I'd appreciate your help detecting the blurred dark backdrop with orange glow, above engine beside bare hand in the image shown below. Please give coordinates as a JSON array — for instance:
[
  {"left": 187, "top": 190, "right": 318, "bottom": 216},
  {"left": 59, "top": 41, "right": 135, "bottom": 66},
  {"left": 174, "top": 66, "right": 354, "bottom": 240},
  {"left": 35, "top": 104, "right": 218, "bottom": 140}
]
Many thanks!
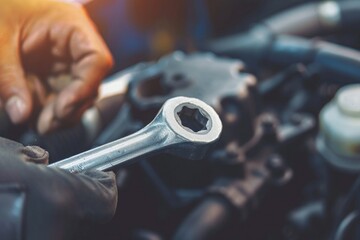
[{"left": 87, "top": 0, "right": 321, "bottom": 71}]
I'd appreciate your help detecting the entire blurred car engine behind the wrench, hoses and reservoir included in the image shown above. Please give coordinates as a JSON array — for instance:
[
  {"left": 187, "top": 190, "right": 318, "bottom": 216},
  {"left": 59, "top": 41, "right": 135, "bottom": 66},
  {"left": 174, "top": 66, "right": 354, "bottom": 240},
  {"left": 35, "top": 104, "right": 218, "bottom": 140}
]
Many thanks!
[{"left": 0, "top": 0, "right": 360, "bottom": 240}]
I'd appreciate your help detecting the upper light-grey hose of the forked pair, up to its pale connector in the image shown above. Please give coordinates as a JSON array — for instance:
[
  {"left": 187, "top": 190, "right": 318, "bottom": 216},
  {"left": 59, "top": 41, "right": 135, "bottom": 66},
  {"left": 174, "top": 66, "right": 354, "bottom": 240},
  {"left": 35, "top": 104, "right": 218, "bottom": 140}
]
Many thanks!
[{"left": 205, "top": 3, "right": 322, "bottom": 59}]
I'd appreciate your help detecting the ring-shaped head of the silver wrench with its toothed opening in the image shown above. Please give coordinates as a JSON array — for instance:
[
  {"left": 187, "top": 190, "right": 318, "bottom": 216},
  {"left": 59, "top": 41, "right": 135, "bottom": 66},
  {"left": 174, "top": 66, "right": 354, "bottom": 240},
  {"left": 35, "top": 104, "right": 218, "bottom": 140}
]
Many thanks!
[{"left": 160, "top": 97, "right": 222, "bottom": 159}]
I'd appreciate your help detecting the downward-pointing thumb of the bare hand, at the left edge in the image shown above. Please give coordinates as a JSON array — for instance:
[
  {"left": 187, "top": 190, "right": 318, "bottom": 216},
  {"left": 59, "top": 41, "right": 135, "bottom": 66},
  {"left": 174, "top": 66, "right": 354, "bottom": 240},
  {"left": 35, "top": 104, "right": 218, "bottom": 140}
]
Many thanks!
[{"left": 0, "top": 29, "right": 32, "bottom": 124}]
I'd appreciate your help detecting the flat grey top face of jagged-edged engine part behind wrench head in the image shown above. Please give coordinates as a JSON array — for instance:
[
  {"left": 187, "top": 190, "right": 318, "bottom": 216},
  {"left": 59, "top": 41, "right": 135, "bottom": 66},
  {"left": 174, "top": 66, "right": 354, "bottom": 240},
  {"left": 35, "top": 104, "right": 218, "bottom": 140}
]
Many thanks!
[{"left": 129, "top": 52, "right": 257, "bottom": 110}]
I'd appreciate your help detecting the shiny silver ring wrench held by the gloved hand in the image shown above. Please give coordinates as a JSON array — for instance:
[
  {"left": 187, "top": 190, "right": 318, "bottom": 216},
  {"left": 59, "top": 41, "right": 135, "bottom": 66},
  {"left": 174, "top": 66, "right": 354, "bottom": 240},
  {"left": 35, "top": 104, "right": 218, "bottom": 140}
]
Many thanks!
[{"left": 49, "top": 97, "right": 222, "bottom": 173}]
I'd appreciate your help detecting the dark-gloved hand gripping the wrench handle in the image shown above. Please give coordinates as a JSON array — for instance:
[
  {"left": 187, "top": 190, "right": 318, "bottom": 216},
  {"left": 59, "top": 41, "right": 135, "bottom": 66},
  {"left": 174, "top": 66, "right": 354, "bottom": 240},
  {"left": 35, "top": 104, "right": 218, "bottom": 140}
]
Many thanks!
[{"left": 0, "top": 138, "right": 117, "bottom": 240}]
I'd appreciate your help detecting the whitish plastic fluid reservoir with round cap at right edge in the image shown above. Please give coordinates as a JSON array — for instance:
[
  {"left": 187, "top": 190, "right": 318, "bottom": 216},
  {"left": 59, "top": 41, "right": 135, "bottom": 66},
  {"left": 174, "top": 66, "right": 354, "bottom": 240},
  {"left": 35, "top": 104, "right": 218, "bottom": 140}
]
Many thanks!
[{"left": 317, "top": 84, "right": 360, "bottom": 172}]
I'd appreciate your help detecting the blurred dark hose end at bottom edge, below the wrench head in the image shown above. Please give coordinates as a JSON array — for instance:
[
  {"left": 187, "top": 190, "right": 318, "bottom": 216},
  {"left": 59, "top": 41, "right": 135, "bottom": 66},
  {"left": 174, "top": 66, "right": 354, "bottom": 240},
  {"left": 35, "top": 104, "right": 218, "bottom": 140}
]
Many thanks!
[{"left": 173, "top": 197, "right": 235, "bottom": 240}]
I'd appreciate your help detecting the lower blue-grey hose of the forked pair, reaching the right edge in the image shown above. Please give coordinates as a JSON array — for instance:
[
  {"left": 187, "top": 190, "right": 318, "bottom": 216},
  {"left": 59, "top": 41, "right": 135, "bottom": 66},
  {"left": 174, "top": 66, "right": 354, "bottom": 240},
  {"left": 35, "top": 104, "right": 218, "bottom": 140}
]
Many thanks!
[{"left": 211, "top": 28, "right": 360, "bottom": 82}]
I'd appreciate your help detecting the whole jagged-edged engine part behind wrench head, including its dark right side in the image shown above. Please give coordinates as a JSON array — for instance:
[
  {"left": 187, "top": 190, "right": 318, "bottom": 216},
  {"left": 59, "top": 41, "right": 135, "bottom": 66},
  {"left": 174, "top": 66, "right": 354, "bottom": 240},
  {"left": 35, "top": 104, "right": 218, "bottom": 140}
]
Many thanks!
[{"left": 128, "top": 52, "right": 259, "bottom": 142}]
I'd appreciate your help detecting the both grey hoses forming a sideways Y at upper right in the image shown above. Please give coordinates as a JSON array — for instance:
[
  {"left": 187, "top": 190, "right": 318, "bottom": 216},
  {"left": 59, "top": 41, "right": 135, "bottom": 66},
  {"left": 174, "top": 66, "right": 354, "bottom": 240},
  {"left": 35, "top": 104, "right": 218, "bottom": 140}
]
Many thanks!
[{"left": 207, "top": 1, "right": 360, "bottom": 76}]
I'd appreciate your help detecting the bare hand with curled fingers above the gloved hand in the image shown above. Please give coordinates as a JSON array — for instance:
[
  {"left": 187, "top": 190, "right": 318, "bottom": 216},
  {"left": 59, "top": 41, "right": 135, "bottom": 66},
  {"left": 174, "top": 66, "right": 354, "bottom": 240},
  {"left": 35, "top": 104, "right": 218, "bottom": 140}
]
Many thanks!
[{"left": 0, "top": 0, "right": 113, "bottom": 134}]
